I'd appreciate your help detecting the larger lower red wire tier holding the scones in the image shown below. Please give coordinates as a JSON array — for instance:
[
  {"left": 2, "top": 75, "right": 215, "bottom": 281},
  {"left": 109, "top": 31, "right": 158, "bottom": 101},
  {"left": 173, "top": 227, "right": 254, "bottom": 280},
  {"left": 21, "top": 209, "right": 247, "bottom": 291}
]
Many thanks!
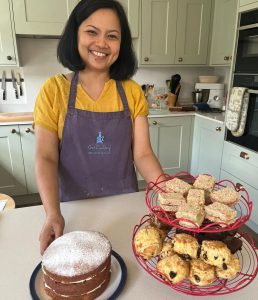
[{"left": 132, "top": 215, "right": 258, "bottom": 296}]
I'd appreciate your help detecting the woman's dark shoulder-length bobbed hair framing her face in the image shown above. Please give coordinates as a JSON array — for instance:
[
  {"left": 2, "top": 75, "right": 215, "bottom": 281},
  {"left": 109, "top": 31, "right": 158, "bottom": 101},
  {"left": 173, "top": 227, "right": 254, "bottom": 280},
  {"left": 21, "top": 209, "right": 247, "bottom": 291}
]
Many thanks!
[{"left": 57, "top": 0, "right": 137, "bottom": 80}]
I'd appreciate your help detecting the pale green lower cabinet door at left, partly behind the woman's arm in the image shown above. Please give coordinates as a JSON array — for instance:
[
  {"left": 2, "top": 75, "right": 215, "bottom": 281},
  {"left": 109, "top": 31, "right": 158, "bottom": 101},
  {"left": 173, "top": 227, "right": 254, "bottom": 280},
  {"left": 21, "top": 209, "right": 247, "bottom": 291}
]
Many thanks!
[{"left": 19, "top": 125, "right": 38, "bottom": 194}]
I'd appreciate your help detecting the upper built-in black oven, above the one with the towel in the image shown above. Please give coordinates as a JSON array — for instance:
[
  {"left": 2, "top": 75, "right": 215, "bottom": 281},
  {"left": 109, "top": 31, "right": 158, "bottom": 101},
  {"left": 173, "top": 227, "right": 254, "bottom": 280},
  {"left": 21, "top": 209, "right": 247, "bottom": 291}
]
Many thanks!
[{"left": 234, "top": 9, "right": 258, "bottom": 74}]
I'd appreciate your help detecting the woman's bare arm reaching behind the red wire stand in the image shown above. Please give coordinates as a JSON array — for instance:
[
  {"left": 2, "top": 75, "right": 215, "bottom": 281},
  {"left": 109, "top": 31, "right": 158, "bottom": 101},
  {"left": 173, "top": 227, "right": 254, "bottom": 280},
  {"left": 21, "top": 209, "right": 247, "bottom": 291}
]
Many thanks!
[{"left": 133, "top": 116, "right": 164, "bottom": 183}]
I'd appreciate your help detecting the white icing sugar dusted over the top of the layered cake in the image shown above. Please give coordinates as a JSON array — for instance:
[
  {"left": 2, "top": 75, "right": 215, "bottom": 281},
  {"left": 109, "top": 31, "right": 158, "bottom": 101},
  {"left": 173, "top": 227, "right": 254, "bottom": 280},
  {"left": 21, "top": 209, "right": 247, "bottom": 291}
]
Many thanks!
[{"left": 42, "top": 231, "right": 111, "bottom": 277}]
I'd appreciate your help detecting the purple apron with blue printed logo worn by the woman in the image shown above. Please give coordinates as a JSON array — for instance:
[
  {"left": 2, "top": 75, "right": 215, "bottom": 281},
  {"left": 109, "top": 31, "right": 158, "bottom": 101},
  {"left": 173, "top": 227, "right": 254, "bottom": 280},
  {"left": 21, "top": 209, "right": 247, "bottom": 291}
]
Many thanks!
[{"left": 59, "top": 72, "right": 138, "bottom": 201}]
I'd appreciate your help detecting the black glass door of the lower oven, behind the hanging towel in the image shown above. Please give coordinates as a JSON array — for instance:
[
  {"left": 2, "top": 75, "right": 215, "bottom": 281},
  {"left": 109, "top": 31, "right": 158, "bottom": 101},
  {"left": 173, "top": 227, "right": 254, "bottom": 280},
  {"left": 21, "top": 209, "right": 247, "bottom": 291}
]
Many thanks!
[{"left": 226, "top": 89, "right": 258, "bottom": 152}]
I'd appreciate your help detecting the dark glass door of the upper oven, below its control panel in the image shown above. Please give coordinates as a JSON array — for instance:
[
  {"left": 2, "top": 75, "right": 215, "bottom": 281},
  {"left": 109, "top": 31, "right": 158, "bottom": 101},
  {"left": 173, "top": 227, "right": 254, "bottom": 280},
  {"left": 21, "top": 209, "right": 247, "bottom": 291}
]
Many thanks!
[{"left": 235, "top": 24, "right": 258, "bottom": 74}]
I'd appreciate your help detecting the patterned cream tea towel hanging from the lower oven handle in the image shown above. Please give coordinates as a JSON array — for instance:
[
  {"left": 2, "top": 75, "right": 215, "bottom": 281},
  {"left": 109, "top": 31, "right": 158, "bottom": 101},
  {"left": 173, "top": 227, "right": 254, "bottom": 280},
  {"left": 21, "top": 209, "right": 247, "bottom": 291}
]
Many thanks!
[{"left": 226, "top": 87, "right": 247, "bottom": 131}]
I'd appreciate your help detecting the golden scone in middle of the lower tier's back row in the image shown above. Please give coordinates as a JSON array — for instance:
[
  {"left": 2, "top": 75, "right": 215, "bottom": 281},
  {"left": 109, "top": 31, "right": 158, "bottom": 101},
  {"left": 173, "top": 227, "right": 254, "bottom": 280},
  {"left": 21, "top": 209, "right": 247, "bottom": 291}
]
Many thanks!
[{"left": 172, "top": 233, "right": 199, "bottom": 258}]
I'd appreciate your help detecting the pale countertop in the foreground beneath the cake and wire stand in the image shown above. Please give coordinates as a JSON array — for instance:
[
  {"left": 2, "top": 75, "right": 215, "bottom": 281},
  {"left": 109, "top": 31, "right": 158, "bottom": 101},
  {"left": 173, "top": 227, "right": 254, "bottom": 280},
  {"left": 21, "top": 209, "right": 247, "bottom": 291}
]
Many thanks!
[{"left": 0, "top": 192, "right": 258, "bottom": 300}]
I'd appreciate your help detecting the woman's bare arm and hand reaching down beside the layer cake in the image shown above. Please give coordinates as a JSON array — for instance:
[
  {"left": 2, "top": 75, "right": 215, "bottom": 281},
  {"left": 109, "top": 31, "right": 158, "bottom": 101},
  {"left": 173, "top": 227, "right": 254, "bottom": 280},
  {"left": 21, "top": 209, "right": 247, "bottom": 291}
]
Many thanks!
[{"left": 35, "top": 125, "right": 64, "bottom": 254}]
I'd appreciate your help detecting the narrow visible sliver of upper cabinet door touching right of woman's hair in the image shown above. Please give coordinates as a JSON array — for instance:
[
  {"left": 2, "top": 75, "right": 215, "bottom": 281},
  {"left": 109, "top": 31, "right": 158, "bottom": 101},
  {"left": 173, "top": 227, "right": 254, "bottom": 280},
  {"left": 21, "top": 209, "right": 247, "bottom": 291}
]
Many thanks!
[{"left": 119, "top": 0, "right": 140, "bottom": 38}]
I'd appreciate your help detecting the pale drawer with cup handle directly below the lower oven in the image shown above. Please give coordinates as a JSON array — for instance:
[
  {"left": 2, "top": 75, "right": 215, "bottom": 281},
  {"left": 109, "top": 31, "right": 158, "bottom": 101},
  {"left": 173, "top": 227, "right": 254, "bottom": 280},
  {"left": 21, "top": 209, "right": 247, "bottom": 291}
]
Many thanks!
[{"left": 221, "top": 142, "right": 258, "bottom": 189}]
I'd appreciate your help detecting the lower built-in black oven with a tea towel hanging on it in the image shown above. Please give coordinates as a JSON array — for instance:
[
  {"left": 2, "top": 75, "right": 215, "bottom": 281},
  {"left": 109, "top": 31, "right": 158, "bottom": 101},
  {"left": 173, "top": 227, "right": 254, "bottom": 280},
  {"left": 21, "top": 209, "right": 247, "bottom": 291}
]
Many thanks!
[{"left": 226, "top": 74, "right": 258, "bottom": 152}]
